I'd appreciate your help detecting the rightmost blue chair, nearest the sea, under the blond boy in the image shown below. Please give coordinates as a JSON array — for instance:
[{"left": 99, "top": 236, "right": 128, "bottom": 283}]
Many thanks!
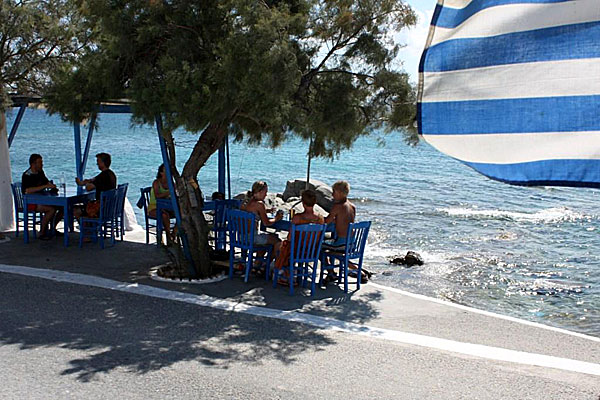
[{"left": 319, "top": 221, "right": 371, "bottom": 293}]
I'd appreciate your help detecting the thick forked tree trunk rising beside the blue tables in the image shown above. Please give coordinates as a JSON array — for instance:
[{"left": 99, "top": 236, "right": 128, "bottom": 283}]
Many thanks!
[{"left": 164, "top": 124, "right": 227, "bottom": 278}]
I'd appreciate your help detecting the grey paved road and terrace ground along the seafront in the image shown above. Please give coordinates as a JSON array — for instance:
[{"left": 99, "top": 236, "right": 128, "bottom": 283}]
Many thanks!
[{"left": 0, "top": 228, "right": 600, "bottom": 400}]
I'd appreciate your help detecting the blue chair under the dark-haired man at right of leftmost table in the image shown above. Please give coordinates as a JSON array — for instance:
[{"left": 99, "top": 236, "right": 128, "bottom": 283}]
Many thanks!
[{"left": 79, "top": 189, "right": 117, "bottom": 249}]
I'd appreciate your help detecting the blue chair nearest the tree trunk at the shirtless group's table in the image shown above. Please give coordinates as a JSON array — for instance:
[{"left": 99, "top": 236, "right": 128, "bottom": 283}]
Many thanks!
[{"left": 226, "top": 209, "right": 273, "bottom": 282}]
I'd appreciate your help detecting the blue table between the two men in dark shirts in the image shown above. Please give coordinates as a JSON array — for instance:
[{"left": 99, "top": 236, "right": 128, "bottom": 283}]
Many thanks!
[{"left": 23, "top": 190, "right": 96, "bottom": 247}]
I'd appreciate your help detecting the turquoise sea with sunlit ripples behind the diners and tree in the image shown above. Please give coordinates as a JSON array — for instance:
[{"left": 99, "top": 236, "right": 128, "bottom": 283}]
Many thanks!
[{"left": 9, "top": 109, "right": 600, "bottom": 336}]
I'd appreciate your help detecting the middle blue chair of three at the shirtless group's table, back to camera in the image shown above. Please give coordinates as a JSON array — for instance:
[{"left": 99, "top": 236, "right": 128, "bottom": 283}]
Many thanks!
[{"left": 273, "top": 224, "right": 327, "bottom": 296}]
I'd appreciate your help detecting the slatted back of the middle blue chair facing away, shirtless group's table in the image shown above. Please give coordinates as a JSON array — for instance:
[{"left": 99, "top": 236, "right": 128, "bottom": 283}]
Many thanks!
[{"left": 290, "top": 224, "right": 327, "bottom": 267}]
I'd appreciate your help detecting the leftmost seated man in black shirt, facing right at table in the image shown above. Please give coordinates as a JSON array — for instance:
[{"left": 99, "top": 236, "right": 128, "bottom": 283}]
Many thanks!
[{"left": 21, "top": 154, "right": 63, "bottom": 240}]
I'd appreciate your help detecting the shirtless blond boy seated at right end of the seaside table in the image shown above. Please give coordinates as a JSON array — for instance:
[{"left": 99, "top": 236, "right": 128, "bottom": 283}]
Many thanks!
[{"left": 323, "top": 181, "right": 356, "bottom": 248}]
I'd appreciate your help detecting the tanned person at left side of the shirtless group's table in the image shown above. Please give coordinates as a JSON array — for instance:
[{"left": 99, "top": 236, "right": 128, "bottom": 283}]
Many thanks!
[{"left": 240, "top": 181, "right": 283, "bottom": 262}]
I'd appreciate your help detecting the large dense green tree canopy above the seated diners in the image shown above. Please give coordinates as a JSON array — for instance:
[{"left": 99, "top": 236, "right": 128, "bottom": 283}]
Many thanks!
[{"left": 48, "top": 0, "right": 415, "bottom": 159}]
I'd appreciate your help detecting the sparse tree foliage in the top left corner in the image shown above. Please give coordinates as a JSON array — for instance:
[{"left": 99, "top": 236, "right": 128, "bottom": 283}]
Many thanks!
[{"left": 0, "top": 0, "right": 86, "bottom": 111}]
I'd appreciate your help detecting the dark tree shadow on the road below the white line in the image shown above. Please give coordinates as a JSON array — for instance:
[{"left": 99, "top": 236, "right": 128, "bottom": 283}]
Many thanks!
[{"left": 0, "top": 274, "right": 336, "bottom": 382}]
